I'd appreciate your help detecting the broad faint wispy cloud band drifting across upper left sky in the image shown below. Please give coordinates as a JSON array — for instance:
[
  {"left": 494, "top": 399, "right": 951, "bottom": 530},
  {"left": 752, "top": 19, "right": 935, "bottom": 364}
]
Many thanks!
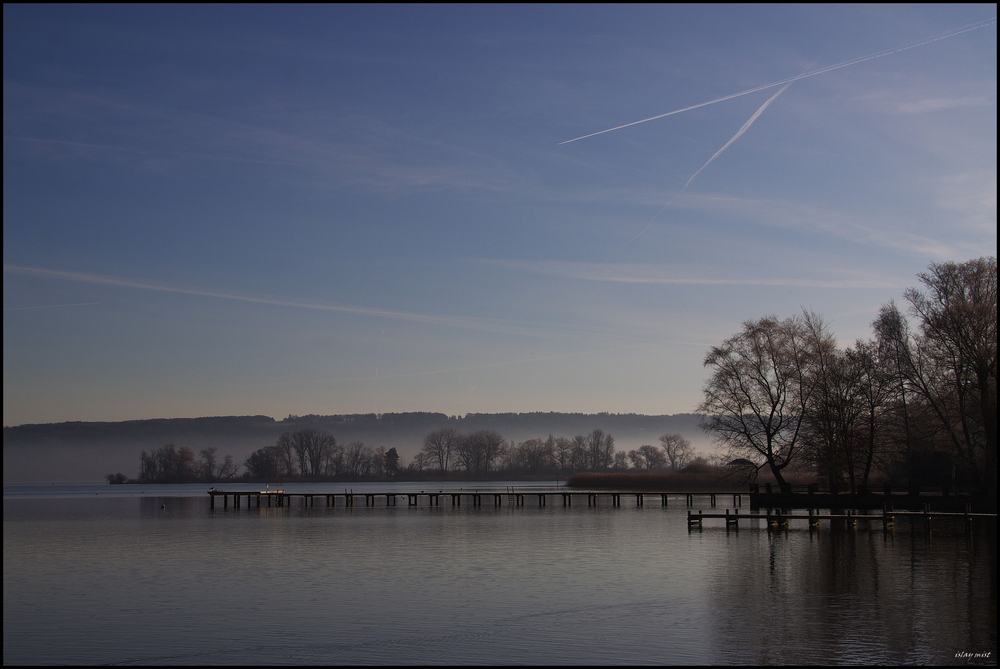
[{"left": 4, "top": 82, "right": 517, "bottom": 192}]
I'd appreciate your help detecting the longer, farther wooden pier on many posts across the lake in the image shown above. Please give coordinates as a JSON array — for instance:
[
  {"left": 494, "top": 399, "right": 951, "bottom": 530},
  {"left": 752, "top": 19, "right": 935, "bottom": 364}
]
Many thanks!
[{"left": 208, "top": 487, "right": 746, "bottom": 509}]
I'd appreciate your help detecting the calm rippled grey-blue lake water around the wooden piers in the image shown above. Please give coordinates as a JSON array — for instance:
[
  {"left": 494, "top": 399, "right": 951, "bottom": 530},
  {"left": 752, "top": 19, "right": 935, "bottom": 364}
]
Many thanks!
[{"left": 3, "top": 483, "right": 997, "bottom": 665}]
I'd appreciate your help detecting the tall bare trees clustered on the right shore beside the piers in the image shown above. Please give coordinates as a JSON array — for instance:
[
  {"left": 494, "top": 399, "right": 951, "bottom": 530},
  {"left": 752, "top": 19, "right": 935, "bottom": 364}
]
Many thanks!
[{"left": 698, "top": 257, "right": 997, "bottom": 504}]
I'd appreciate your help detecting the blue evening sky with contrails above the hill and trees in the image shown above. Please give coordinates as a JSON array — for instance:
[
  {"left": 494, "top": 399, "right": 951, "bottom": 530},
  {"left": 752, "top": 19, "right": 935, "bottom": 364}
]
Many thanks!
[{"left": 3, "top": 4, "right": 997, "bottom": 425}]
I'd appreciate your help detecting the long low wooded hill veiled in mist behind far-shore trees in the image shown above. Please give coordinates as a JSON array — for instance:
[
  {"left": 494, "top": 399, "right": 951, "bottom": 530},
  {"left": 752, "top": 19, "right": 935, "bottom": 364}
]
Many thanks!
[{"left": 3, "top": 412, "right": 708, "bottom": 483}]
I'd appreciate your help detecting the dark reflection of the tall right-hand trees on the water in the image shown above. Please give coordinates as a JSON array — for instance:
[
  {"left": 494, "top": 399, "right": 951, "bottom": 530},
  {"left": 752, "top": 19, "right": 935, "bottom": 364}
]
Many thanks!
[{"left": 705, "top": 527, "right": 996, "bottom": 665}]
